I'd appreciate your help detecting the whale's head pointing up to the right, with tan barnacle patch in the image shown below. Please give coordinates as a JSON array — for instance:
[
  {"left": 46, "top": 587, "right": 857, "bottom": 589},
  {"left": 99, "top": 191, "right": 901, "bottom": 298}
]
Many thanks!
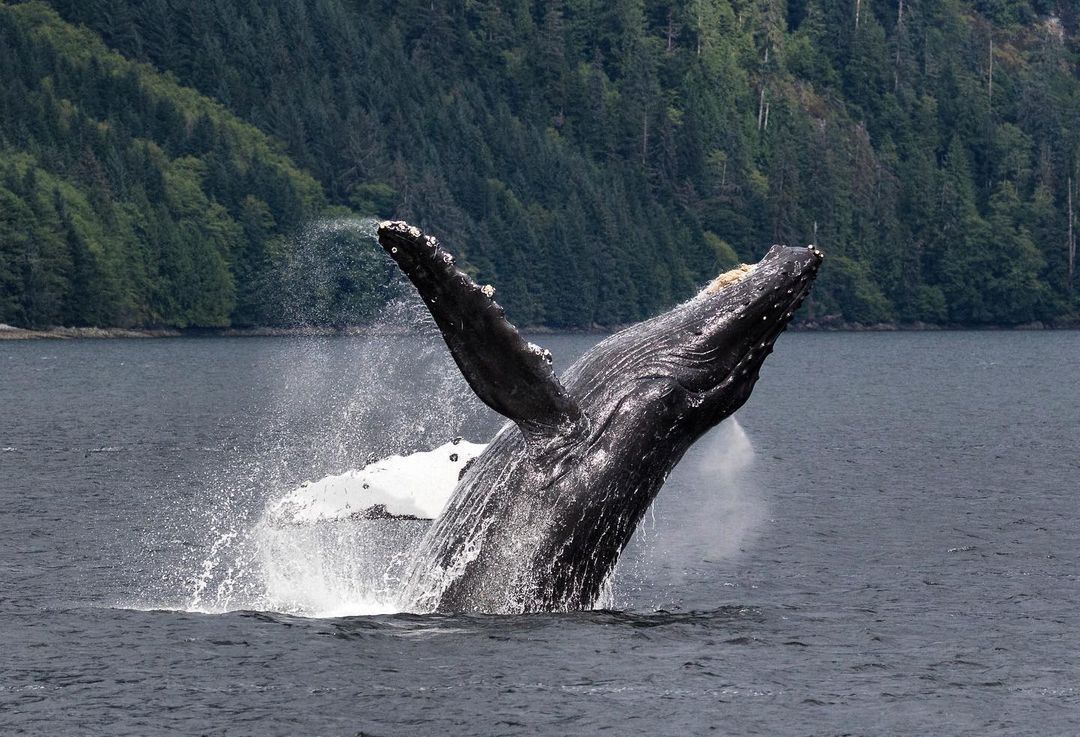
[{"left": 564, "top": 245, "right": 823, "bottom": 438}]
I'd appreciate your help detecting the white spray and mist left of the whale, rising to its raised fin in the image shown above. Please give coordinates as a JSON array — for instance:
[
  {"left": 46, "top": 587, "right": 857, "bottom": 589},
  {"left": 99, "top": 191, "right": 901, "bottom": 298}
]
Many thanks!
[{"left": 135, "top": 219, "right": 486, "bottom": 616}]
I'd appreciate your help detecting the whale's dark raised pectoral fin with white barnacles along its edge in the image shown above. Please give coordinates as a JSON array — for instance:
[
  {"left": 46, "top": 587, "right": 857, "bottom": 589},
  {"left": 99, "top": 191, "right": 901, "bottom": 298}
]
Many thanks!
[{"left": 379, "top": 222, "right": 581, "bottom": 439}]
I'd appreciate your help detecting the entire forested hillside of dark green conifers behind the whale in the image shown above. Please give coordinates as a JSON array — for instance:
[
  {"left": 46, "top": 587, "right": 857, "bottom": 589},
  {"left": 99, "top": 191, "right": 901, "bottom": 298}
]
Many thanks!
[{"left": 0, "top": 0, "right": 1080, "bottom": 326}]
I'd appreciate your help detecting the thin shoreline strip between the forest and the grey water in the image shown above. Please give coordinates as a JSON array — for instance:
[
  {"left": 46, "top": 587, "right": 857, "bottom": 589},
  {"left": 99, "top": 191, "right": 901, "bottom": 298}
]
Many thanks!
[{"left": 0, "top": 321, "right": 1080, "bottom": 341}]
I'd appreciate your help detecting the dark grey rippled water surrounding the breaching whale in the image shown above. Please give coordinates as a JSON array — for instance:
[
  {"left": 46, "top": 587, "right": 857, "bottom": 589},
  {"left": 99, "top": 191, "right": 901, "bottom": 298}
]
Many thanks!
[{"left": 0, "top": 333, "right": 1080, "bottom": 736}]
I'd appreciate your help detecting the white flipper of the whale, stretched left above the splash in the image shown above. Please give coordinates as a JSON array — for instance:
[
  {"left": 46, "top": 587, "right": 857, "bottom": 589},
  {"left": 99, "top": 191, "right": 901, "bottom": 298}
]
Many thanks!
[{"left": 267, "top": 440, "right": 487, "bottom": 525}]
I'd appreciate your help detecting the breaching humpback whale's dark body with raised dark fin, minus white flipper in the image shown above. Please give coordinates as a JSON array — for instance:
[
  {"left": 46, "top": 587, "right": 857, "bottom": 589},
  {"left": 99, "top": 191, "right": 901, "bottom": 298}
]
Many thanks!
[{"left": 378, "top": 222, "right": 823, "bottom": 613}]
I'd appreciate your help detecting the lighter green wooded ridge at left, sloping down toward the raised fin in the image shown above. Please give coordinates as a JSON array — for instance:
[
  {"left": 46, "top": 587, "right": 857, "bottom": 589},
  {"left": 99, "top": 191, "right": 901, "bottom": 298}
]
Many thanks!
[{"left": 0, "top": 3, "right": 382, "bottom": 326}]
